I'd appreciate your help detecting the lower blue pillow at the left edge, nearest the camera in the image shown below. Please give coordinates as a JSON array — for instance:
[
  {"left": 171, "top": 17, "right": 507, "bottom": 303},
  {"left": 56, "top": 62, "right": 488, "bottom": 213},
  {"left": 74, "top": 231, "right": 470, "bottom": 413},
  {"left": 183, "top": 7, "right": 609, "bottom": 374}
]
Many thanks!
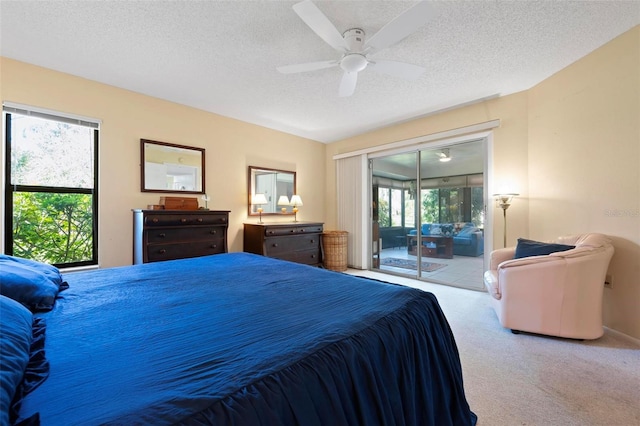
[{"left": 0, "top": 296, "right": 33, "bottom": 425}]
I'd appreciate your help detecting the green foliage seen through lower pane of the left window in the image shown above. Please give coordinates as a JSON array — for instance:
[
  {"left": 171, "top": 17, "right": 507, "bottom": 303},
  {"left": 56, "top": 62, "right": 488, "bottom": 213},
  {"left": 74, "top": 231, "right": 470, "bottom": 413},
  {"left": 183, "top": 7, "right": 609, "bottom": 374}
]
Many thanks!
[{"left": 13, "top": 192, "right": 93, "bottom": 264}]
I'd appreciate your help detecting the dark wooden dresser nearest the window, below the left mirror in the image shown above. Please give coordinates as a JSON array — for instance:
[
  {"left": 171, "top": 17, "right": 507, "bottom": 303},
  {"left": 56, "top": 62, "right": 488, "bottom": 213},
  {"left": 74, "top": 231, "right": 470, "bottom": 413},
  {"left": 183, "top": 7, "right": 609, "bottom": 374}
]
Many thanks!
[{"left": 133, "top": 209, "right": 229, "bottom": 264}]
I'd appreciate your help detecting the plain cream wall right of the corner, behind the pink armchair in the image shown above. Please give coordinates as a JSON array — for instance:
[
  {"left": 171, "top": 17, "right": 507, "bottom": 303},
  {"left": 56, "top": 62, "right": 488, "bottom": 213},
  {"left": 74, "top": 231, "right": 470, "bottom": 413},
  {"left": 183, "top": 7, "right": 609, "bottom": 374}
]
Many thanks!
[{"left": 528, "top": 27, "right": 640, "bottom": 338}]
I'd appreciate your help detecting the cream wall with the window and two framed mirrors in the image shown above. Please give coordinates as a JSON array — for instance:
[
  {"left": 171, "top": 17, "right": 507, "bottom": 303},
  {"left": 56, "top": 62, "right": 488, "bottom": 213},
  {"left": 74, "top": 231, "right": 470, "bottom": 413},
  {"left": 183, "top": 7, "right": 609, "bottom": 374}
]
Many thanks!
[{"left": 0, "top": 58, "right": 325, "bottom": 267}]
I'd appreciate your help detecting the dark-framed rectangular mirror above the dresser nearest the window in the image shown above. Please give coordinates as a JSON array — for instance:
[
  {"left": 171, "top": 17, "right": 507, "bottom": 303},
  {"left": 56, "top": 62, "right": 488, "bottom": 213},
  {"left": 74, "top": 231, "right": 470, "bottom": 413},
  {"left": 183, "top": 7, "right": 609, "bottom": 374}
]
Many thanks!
[{"left": 140, "top": 139, "right": 205, "bottom": 194}]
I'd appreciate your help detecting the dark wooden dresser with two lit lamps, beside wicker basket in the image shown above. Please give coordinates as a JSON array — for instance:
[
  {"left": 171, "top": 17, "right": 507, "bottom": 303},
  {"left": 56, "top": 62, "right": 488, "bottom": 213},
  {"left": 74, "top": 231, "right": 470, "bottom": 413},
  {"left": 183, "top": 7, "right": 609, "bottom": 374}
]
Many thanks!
[{"left": 244, "top": 222, "right": 323, "bottom": 266}]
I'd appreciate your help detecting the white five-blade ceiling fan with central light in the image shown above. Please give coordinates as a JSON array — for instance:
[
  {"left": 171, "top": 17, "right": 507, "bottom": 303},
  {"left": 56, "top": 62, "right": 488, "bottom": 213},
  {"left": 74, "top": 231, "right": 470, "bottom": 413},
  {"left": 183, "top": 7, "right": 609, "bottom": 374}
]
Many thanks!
[{"left": 276, "top": 0, "right": 435, "bottom": 97}]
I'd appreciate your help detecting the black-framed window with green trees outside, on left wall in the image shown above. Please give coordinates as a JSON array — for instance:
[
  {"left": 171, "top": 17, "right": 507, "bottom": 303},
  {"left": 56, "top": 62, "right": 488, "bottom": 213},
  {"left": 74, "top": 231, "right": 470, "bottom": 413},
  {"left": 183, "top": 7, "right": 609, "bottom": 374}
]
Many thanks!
[{"left": 4, "top": 106, "right": 99, "bottom": 267}]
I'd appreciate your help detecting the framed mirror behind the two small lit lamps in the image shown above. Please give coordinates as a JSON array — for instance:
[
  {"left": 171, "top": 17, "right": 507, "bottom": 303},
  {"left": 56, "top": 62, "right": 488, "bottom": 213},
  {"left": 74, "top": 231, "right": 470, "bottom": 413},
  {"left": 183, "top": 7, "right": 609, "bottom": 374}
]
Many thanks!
[{"left": 247, "top": 166, "right": 296, "bottom": 216}]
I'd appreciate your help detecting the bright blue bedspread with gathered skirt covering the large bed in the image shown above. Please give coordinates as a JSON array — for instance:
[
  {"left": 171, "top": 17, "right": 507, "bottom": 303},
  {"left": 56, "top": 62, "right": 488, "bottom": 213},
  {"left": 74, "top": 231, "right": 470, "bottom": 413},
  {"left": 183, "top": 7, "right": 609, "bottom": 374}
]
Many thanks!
[{"left": 0, "top": 253, "right": 476, "bottom": 425}]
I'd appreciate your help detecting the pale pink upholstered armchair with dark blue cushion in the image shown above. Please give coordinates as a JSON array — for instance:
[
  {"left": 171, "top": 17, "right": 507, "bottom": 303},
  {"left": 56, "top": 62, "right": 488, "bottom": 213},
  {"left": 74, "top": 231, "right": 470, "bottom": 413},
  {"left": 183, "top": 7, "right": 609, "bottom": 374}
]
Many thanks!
[{"left": 484, "top": 233, "right": 613, "bottom": 339}]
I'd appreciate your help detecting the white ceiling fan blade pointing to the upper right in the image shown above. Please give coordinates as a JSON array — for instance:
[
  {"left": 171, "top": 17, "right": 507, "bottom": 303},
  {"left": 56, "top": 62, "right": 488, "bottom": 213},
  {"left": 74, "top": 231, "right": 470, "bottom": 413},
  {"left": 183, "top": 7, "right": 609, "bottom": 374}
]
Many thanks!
[{"left": 364, "top": 1, "right": 436, "bottom": 53}]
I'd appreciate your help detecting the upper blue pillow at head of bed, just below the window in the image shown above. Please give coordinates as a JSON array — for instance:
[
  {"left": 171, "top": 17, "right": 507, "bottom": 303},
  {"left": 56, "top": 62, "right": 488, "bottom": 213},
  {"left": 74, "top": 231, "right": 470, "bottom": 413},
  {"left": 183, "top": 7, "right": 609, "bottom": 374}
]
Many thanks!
[{"left": 0, "top": 255, "right": 69, "bottom": 312}]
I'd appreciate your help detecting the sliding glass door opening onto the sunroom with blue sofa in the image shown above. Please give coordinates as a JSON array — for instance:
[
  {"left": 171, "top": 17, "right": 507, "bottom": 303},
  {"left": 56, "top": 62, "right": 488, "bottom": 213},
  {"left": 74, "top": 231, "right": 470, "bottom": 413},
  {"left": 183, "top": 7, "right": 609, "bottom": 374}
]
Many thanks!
[{"left": 370, "top": 140, "right": 485, "bottom": 288}]
